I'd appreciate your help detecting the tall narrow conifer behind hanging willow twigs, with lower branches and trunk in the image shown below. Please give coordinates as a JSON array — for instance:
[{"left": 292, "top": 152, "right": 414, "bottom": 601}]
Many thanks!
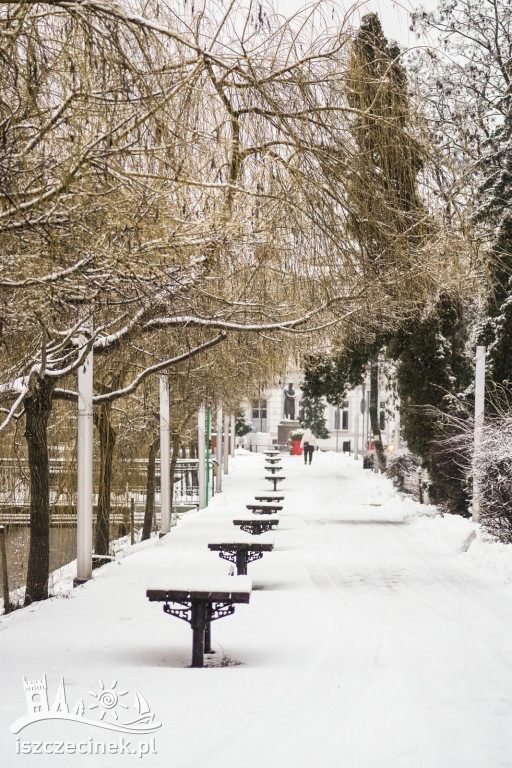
[{"left": 306, "top": 13, "right": 426, "bottom": 470}]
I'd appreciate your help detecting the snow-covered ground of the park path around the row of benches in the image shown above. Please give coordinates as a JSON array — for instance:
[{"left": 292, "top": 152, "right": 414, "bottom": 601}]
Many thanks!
[{"left": 0, "top": 453, "right": 512, "bottom": 768}]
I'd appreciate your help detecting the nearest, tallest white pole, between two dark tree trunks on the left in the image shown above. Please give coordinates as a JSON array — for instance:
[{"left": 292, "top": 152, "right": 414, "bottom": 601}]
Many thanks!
[{"left": 75, "top": 340, "right": 93, "bottom": 584}]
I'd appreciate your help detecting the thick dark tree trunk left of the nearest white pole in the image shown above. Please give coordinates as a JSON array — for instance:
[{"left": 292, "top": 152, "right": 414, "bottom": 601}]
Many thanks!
[{"left": 25, "top": 379, "right": 54, "bottom": 605}]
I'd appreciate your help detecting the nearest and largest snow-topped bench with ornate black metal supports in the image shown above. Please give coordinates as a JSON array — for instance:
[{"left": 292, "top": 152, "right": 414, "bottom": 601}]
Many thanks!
[{"left": 146, "top": 576, "right": 252, "bottom": 667}]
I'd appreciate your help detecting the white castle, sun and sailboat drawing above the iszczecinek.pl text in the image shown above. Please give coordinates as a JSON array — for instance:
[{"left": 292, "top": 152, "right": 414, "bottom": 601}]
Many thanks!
[{"left": 11, "top": 675, "right": 162, "bottom": 734}]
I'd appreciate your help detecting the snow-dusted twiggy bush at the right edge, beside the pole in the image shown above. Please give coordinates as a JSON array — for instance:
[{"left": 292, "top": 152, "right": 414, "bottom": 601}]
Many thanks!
[{"left": 473, "top": 415, "right": 512, "bottom": 544}]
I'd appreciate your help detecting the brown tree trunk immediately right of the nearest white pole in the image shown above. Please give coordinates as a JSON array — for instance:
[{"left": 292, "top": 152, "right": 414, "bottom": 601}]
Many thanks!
[{"left": 94, "top": 403, "right": 117, "bottom": 555}]
